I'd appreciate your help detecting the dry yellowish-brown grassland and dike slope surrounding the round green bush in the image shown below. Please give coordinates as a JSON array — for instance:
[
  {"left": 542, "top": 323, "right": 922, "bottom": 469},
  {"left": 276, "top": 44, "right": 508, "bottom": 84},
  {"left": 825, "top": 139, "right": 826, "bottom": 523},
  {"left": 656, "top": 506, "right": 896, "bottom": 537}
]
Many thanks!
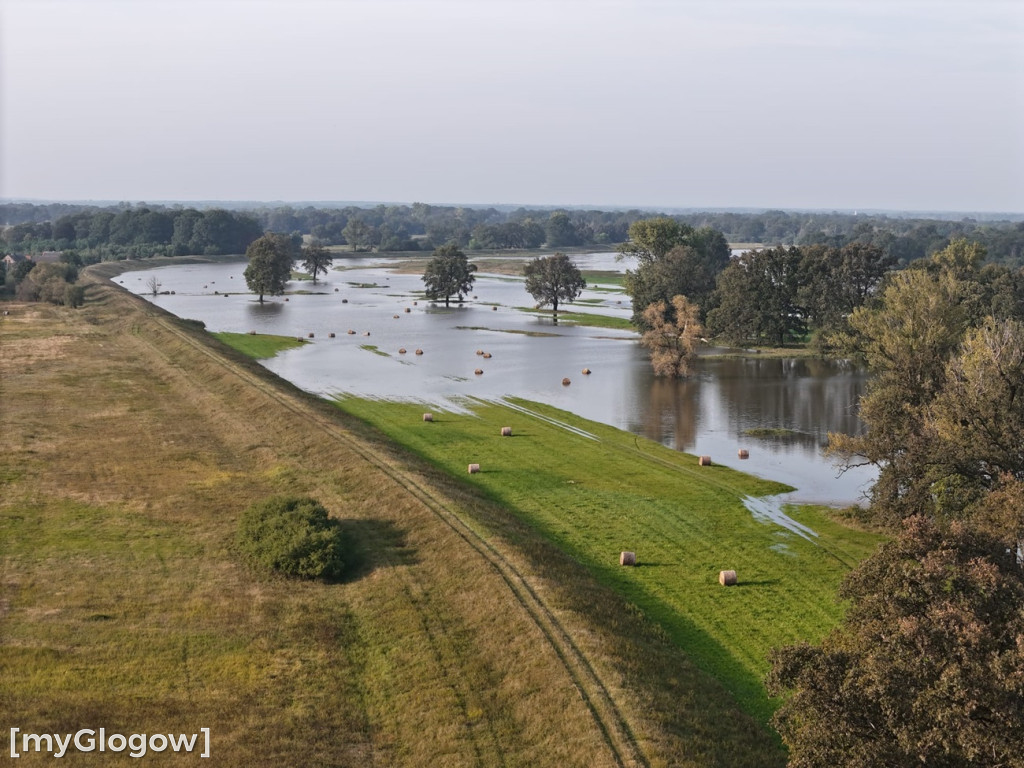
[{"left": 0, "top": 268, "right": 783, "bottom": 768}]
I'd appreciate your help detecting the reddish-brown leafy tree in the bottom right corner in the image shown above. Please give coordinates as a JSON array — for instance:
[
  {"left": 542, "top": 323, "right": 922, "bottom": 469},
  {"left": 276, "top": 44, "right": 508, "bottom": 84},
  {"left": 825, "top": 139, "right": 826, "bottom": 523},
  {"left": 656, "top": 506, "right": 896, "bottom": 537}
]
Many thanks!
[{"left": 767, "top": 517, "right": 1024, "bottom": 768}]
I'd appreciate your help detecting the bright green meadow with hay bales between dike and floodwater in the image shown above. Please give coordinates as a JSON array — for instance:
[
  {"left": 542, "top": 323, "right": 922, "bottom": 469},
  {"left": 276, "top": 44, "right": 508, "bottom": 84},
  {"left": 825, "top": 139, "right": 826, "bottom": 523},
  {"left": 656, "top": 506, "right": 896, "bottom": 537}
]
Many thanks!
[{"left": 331, "top": 398, "right": 880, "bottom": 722}]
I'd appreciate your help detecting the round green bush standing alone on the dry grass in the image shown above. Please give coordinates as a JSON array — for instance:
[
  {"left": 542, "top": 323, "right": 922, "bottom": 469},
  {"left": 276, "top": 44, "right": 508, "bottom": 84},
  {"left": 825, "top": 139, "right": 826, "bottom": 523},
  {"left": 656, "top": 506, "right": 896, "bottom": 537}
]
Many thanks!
[{"left": 238, "top": 497, "right": 344, "bottom": 580}]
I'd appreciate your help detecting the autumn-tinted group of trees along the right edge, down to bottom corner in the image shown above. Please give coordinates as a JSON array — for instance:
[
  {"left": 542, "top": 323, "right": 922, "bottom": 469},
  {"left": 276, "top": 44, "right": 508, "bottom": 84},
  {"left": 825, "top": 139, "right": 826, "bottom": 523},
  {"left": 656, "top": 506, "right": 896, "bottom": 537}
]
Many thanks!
[{"left": 768, "top": 241, "right": 1024, "bottom": 767}]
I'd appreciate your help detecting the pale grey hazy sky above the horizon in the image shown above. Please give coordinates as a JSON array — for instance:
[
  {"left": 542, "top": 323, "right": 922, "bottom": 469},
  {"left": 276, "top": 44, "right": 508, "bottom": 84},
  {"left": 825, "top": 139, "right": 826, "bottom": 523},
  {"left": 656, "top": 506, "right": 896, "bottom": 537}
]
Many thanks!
[{"left": 0, "top": 0, "right": 1024, "bottom": 212}]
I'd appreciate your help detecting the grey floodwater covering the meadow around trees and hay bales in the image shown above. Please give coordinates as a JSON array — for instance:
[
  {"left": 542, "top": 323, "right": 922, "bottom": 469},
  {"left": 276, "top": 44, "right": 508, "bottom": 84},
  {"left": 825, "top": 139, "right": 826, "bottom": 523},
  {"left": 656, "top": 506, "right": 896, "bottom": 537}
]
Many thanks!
[{"left": 118, "top": 254, "right": 874, "bottom": 505}]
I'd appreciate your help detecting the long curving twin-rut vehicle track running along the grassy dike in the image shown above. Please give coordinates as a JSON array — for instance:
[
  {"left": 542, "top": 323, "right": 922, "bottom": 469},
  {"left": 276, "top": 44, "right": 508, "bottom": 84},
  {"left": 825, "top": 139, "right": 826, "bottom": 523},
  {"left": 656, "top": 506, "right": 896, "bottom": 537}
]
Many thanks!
[{"left": 116, "top": 284, "right": 649, "bottom": 768}]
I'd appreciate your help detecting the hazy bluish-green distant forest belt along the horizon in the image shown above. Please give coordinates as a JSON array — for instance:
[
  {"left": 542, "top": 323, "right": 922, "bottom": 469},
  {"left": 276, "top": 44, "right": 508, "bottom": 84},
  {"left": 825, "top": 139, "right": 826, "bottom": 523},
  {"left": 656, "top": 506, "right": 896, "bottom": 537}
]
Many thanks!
[{"left": 6, "top": 203, "right": 1024, "bottom": 266}]
